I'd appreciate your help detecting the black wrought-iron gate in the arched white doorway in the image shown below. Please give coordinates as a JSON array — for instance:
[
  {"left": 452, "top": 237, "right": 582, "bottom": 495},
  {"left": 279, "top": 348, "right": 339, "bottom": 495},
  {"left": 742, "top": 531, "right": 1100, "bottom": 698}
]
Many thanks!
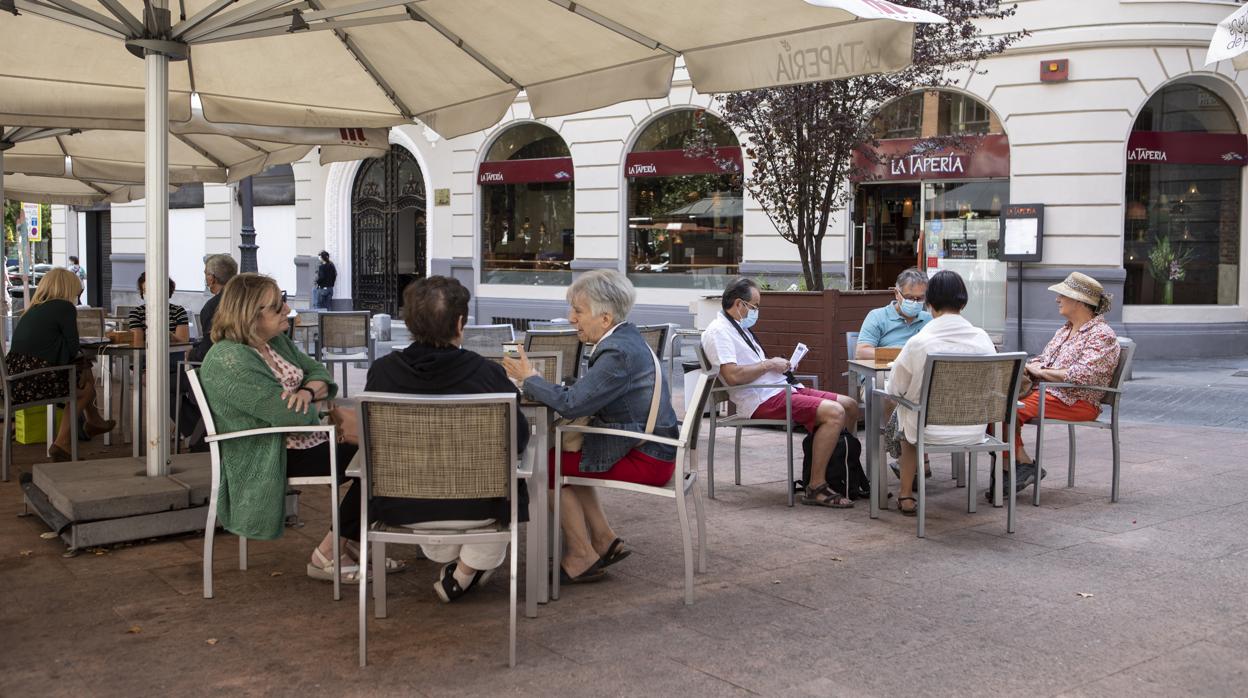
[{"left": 351, "top": 146, "right": 426, "bottom": 315}]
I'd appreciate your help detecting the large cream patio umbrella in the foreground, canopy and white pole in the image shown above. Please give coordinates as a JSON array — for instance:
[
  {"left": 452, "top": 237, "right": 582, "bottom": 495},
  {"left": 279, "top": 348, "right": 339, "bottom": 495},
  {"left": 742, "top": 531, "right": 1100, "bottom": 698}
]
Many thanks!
[{"left": 0, "top": 0, "right": 945, "bottom": 474}]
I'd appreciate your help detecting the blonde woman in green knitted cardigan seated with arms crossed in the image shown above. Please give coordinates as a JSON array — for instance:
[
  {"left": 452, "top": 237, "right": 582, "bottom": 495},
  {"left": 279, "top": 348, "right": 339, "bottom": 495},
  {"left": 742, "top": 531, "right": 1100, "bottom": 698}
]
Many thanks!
[{"left": 198, "top": 273, "right": 371, "bottom": 583}]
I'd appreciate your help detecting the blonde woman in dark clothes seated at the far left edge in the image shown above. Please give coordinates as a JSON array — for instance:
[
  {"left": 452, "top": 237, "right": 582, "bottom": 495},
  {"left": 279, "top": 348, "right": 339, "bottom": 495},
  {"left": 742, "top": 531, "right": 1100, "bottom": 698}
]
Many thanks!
[{"left": 5, "top": 268, "right": 116, "bottom": 461}]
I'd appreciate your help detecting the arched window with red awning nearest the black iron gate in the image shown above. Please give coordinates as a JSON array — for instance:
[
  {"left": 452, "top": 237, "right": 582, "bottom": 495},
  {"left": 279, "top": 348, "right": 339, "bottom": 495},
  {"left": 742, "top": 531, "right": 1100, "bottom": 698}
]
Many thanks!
[{"left": 477, "top": 122, "right": 575, "bottom": 285}]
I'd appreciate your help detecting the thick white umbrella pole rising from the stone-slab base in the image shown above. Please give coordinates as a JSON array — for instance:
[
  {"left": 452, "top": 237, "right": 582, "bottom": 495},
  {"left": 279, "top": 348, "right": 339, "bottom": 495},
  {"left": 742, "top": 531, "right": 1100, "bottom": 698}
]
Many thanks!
[{"left": 144, "top": 43, "right": 170, "bottom": 477}]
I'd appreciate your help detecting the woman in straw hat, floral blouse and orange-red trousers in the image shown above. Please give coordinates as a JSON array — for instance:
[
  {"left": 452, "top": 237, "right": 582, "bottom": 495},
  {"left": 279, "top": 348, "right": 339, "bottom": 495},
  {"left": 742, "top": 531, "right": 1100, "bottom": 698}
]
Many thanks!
[{"left": 1003, "top": 271, "right": 1119, "bottom": 498}]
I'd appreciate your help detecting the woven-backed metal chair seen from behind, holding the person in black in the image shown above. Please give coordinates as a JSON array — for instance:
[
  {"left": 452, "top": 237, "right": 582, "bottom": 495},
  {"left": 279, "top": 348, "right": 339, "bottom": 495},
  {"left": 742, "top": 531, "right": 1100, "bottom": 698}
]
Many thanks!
[{"left": 359, "top": 392, "right": 521, "bottom": 667}]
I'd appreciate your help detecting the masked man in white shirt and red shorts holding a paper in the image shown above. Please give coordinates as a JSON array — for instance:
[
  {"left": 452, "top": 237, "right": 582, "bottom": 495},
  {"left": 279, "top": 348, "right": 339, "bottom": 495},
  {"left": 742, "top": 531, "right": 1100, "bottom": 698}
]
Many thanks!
[{"left": 701, "top": 278, "right": 857, "bottom": 508}]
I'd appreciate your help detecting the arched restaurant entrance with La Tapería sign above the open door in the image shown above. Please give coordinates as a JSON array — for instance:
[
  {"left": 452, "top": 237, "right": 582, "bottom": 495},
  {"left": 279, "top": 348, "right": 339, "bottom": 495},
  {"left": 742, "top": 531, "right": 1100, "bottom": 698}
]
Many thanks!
[{"left": 849, "top": 90, "right": 1010, "bottom": 340}]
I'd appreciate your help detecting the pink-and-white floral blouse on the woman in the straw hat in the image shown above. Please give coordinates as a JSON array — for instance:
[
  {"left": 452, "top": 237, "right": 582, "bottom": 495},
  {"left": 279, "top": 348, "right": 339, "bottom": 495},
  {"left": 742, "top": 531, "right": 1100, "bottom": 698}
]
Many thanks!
[{"left": 1036, "top": 315, "right": 1121, "bottom": 406}]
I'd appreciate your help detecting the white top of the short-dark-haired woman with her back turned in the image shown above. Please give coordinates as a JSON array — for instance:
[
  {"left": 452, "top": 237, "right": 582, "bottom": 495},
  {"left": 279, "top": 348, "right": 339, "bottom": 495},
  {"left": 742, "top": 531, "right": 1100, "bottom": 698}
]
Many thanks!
[{"left": 885, "top": 313, "right": 997, "bottom": 443}]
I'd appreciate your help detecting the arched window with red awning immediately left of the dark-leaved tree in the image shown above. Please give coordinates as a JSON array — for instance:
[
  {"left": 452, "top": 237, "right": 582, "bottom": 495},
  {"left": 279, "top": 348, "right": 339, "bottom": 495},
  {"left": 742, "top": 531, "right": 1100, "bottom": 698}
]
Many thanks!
[{"left": 624, "top": 109, "right": 743, "bottom": 290}]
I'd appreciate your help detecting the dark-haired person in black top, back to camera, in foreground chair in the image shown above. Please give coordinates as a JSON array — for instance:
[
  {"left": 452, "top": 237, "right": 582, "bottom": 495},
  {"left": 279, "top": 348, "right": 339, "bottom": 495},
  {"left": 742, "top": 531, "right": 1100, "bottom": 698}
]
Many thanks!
[{"left": 342, "top": 276, "right": 529, "bottom": 603}]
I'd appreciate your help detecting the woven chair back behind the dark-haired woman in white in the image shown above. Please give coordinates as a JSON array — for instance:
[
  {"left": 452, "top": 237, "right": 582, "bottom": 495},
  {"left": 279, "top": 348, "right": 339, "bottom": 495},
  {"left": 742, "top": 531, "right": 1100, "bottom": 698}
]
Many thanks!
[{"left": 925, "top": 353, "right": 1027, "bottom": 427}]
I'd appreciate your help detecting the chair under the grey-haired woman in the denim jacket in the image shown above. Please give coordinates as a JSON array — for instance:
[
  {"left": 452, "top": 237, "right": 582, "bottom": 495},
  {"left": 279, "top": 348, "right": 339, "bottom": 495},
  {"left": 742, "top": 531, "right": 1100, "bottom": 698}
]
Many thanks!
[{"left": 550, "top": 372, "right": 715, "bottom": 606}]
